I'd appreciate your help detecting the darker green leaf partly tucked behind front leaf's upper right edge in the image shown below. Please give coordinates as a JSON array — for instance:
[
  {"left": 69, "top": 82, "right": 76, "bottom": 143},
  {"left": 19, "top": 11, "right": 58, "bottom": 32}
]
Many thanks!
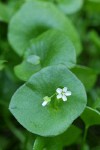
[{"left": 71, "top": 66, "right": 97, "bottom": 91}]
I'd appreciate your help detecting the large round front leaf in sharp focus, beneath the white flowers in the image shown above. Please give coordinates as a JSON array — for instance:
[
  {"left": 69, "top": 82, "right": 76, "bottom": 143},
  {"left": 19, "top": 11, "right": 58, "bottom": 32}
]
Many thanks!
[{"left": 9, "top": 65, "right": 86, "bottom": 136}]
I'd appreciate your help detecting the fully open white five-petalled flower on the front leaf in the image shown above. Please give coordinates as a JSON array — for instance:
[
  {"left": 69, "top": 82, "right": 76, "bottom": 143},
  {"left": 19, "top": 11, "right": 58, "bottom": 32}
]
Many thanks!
[{"left": 56, "top": 87, "right": 71, "bottom": 101}]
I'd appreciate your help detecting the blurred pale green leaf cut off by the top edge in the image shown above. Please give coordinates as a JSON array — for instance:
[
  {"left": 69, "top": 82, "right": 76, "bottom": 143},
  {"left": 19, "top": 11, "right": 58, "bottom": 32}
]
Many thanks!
[{"left": 57, "top": 0, "right": 83, "bottom": 14}]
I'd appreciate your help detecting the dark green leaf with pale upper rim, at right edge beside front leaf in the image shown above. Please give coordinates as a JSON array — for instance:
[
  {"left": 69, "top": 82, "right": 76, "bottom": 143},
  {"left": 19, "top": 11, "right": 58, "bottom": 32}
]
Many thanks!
[{"left": 81, "top": 107, "right": 100, "bottom": 127}]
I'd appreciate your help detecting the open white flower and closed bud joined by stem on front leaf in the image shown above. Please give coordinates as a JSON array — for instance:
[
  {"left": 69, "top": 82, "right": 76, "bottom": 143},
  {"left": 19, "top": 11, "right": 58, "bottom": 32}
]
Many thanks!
[{"left": 42, "top": 87, "right": 72, "bottom": 106}]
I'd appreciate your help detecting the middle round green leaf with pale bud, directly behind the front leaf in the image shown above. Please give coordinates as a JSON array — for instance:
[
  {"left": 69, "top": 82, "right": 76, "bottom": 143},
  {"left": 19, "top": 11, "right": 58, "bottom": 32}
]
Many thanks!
[{"left": 15, "top": 30, "right": 76, "bottom": 81}]
